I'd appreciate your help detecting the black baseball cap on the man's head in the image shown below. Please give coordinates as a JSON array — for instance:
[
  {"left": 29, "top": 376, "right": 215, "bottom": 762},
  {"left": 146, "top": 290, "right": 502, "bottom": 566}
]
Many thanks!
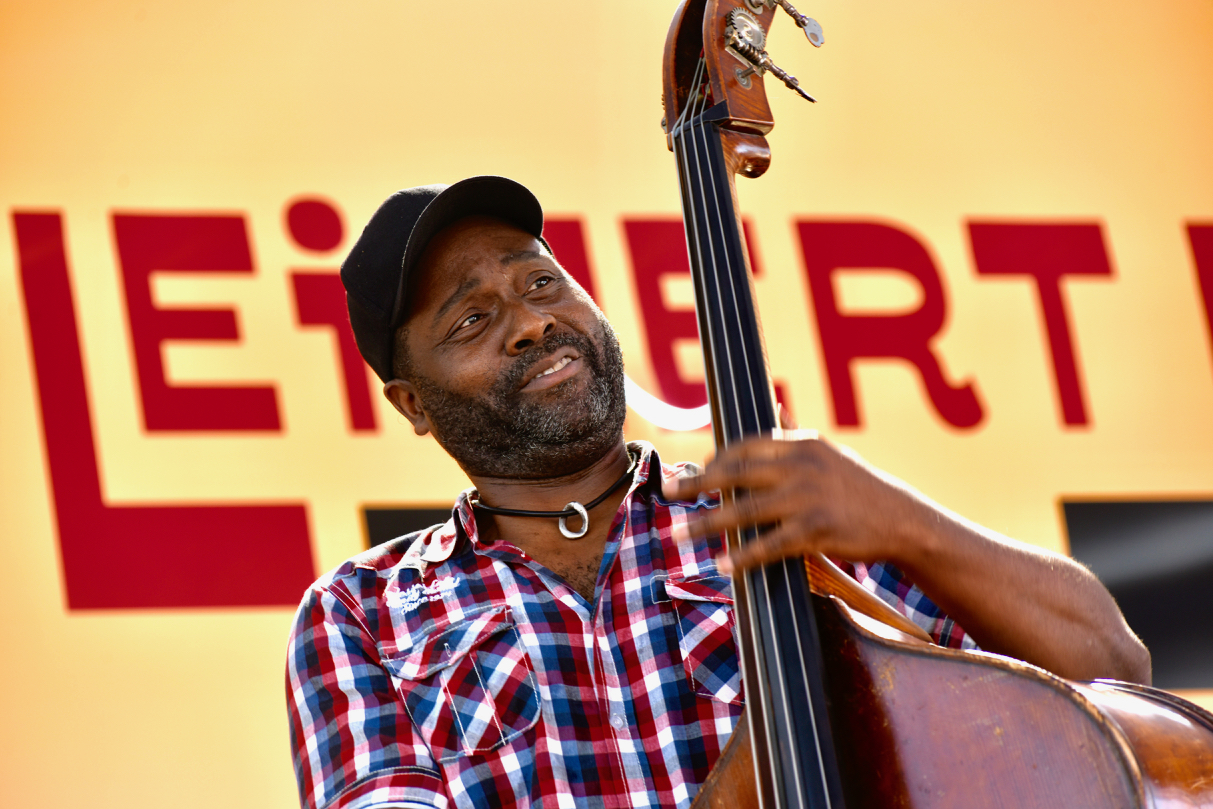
[{"left": 341, "top": 176, "right": 546, "bottom": 382}]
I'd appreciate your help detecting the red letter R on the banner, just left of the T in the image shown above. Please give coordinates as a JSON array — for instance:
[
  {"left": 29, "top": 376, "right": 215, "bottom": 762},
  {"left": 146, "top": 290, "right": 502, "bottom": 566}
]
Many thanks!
[{"left": 797, "top": 222, "right": 984, "bottom": 427}]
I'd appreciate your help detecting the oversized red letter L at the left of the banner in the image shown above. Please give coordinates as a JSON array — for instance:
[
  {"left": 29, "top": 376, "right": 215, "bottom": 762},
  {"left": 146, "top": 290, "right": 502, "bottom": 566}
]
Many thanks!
[{"left": 12, "top": 213, "right": 315, "bottom": 609}]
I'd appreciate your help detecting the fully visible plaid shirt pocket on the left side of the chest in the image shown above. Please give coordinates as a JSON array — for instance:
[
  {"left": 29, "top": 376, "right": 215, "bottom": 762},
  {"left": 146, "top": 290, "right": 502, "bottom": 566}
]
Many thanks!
[{"left": 383, "top": 608, "right": 540, "bottom": 762}]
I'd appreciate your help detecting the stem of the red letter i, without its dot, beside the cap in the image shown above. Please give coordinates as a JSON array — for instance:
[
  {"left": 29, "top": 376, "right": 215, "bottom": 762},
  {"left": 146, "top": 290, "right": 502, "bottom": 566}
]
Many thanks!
[{"left": 291, "top": 273, "right": 375, "bottom": 431}]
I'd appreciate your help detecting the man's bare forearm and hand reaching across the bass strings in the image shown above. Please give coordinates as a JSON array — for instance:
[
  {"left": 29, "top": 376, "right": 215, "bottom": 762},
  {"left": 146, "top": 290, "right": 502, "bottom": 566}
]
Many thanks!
[{"left": 666, "top": 431, "right": 1150, "bottom": 683}]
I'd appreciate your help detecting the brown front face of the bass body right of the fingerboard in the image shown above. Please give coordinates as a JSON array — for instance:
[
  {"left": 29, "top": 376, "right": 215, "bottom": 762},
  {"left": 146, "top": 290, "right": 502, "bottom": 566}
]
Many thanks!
[{"left": 818, "top": 602, "right": 1146, "bottom": 809}]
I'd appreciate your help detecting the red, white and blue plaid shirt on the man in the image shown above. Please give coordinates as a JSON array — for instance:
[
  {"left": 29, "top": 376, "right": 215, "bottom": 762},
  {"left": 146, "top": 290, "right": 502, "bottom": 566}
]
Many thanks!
[{"left": 287, "top": 444, "right": 972, "bottom": 809}]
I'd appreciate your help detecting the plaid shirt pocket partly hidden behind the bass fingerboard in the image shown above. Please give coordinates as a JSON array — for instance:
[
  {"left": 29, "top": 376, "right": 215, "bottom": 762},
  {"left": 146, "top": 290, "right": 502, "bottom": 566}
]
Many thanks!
[{"left": 665, "top": 576, "right": 744, "bottom": 705}]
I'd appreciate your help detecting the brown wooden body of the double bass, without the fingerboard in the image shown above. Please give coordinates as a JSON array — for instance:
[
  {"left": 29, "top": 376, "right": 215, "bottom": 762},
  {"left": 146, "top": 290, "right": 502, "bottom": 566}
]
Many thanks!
[{"left": 693, "top": 596, "right": 1213, "bottom": 809}]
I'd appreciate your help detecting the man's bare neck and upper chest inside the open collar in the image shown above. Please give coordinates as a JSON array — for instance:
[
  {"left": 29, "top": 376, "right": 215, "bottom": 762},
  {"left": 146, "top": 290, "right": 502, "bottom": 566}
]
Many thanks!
[{"left": 472, "top": 440, "right": 630, "bottom": 600}]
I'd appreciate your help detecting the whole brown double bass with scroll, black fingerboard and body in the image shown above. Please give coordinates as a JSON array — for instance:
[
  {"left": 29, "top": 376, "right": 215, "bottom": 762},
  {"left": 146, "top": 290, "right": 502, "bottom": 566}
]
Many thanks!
[{"left": 662, "top": 0, "right": 1213, "bottom": 809}]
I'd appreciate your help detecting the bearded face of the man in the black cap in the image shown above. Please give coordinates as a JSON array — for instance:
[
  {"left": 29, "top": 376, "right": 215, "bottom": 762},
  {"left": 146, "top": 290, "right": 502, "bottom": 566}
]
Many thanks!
[{"left": 388, "top": 217, "right": 627, "bottom": 478}]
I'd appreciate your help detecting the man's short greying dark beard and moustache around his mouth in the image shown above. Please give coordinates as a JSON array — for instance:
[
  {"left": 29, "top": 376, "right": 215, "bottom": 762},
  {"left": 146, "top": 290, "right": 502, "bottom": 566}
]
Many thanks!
[{"left": 412, "top": 317, "right": 627, "bottom": 479}]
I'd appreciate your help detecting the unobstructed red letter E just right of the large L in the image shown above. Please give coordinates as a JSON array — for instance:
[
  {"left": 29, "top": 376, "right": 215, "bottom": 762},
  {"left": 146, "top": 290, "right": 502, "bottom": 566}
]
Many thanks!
[{"left": 114, "top": 213, "right": 281, "bottom": 431}]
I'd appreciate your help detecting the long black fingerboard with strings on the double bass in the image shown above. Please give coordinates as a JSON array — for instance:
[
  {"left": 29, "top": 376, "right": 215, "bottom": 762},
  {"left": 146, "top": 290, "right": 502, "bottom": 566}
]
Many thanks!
[{"left": 671, "top": 69, "right": 843, "bottom": 809}]
